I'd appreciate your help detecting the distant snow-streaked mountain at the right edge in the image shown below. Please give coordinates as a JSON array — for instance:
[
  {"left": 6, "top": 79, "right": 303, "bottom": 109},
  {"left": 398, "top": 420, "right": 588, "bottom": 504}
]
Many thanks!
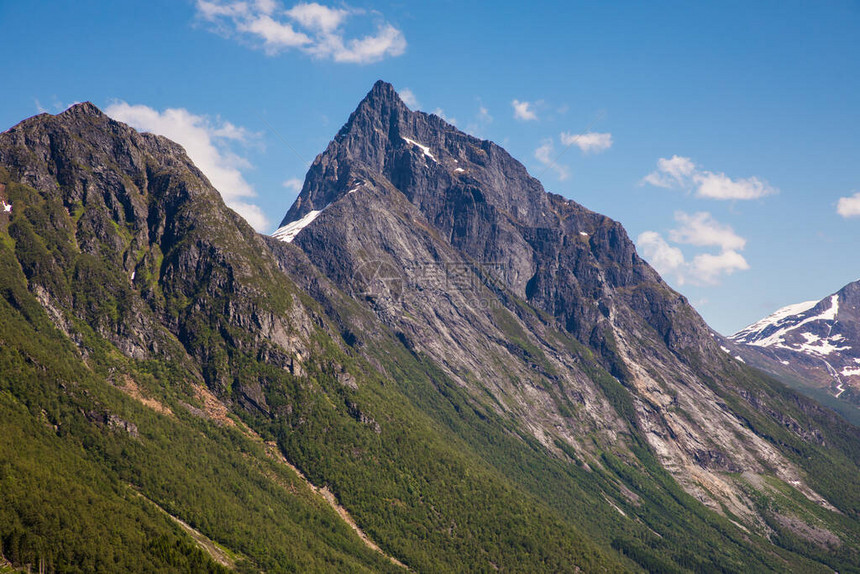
[{"left": 729, "top": 281, "right": 860, "bottom": 420}]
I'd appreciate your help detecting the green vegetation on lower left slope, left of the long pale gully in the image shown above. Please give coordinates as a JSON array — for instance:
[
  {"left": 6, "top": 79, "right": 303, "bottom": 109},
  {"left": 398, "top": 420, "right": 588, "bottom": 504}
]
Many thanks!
[{"left": 0, "top": 178, "right": 400, "bottom": 572}]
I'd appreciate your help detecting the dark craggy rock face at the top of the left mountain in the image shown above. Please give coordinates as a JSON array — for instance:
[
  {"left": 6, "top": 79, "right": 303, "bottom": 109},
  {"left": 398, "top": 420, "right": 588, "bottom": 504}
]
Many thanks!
[{"left": 0, "top": 103, "right": 310, "bottom": 395}]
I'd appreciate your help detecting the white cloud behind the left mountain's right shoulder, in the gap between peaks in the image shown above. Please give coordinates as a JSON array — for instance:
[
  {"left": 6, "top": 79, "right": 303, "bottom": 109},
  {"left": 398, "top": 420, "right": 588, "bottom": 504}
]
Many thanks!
[{"left": 105, "top": 102, "right": 268, "bottom": 231}]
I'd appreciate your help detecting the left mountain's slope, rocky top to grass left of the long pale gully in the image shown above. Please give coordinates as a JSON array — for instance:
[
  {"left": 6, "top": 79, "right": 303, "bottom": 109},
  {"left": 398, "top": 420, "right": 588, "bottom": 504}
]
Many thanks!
[{"left": 0, "top": 104, "right": 408, "bottom": 572}]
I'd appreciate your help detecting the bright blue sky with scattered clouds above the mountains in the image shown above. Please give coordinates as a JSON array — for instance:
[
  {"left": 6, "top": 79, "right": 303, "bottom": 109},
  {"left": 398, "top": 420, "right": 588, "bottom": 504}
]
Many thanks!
[{"left": 0, "top": 0, "right": 860, "bottom": 333}]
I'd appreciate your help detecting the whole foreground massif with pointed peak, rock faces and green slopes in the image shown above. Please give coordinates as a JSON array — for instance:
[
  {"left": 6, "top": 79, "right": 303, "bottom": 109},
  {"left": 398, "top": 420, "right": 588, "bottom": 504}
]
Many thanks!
[{"left": 0, "top": 86, "right": 860, "bottom": 572}]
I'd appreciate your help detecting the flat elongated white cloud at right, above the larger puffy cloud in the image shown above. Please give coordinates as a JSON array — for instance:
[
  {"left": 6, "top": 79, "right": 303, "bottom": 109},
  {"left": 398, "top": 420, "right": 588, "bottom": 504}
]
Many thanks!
[{"left": 641, "top": 155, "right": 778, "bottom": 200}]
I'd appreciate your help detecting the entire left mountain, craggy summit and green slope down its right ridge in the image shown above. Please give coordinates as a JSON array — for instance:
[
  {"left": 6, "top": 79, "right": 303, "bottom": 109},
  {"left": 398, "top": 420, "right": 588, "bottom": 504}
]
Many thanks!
[{"left": 0, "top": 104, "right": 629, "bottom": 572}]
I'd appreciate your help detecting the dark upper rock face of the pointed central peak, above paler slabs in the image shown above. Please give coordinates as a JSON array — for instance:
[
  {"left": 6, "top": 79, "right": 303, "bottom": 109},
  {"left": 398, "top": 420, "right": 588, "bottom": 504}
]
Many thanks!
[{"left": 282, "top": 82, "right": 715, "bottom": 364}]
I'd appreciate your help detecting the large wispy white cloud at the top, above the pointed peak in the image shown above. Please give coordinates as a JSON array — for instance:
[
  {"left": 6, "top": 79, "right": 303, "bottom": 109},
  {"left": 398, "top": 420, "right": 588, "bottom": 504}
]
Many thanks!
[{"left": 196, "top": 0, "right": 406, "bottom": 64}]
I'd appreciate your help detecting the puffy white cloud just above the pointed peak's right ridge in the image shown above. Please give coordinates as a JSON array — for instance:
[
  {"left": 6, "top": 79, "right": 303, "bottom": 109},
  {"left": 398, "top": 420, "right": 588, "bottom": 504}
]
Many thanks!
[{"left": 636, "top": 212, "right": 750, "bottom": 285}]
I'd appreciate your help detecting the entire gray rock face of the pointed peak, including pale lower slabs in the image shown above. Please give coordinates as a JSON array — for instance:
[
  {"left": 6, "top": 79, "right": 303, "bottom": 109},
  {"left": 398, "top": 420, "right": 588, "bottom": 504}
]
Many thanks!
[{"left": 282, "top": 82, "right": 848, "bottom": 522}]
